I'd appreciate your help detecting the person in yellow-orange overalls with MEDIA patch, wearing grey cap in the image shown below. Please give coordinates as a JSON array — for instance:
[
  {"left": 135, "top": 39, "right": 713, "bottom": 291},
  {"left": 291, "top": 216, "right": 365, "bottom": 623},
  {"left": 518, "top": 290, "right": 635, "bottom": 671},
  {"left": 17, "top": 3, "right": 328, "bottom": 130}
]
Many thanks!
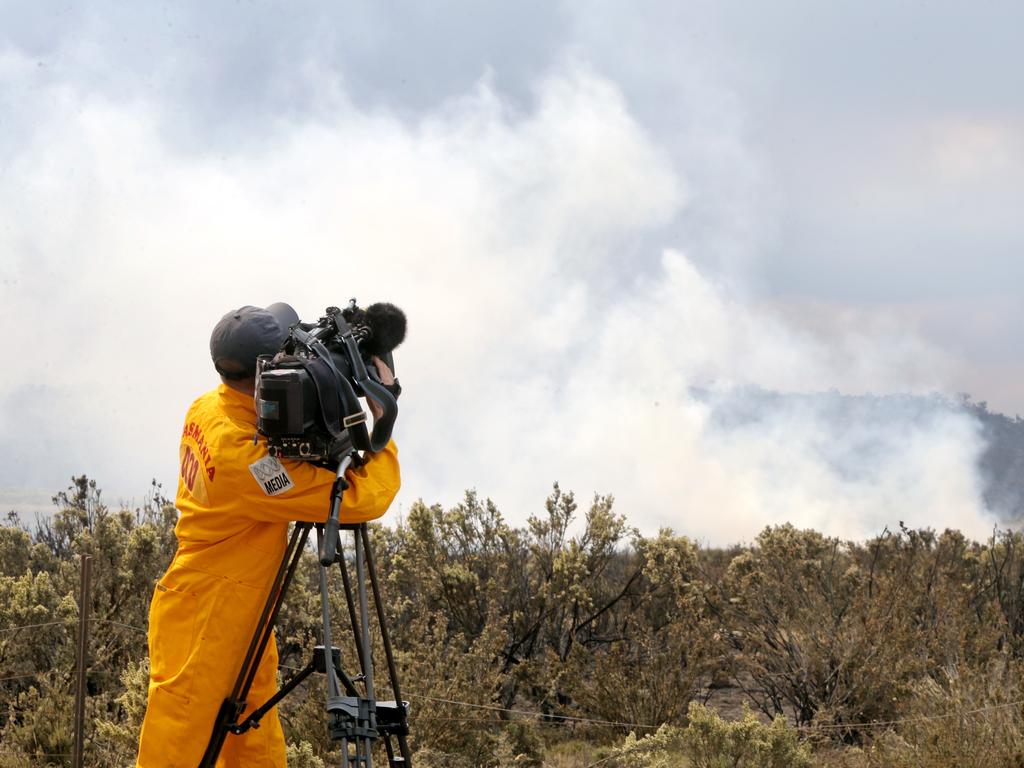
[{"left": 136, "top": 303, "right": 399, "bottom": 768}]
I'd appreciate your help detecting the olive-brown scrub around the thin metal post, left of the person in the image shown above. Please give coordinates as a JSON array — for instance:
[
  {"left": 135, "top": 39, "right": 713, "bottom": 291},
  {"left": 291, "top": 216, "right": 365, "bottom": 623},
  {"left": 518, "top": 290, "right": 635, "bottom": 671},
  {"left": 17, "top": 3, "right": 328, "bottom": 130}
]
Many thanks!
[{"left": 0, "top": 476, "right": 175, "bottom": 767}]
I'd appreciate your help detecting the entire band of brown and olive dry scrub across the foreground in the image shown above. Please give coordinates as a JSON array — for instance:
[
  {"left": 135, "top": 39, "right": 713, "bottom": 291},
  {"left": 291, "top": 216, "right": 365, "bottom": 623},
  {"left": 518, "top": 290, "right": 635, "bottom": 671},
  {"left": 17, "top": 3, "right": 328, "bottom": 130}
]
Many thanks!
[{"left": 6, "top": 477, "right": 1024, "bottom": 768}]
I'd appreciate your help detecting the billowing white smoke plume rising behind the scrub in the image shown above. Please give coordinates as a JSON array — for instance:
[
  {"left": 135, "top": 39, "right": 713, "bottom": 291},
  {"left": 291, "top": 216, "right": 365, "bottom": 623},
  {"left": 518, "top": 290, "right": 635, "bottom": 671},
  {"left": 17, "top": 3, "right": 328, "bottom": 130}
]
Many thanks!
[{"left": 0, "top": 53, "right": 989, "bottom": 543}]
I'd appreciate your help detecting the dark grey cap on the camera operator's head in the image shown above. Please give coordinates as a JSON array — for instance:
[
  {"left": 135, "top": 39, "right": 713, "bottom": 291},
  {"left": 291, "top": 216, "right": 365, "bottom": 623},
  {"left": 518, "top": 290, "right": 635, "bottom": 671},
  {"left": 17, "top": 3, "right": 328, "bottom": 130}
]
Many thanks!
[{"left": 210, "top": 302, "right": 299, "bottom": 379}]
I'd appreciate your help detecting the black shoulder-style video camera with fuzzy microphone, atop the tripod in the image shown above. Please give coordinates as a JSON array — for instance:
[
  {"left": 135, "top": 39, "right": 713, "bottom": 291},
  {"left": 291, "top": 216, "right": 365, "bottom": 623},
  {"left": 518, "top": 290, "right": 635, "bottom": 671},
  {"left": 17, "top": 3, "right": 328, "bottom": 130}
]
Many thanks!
[{"left": 256, "top": 299, "right": 406, "bottom": 464}]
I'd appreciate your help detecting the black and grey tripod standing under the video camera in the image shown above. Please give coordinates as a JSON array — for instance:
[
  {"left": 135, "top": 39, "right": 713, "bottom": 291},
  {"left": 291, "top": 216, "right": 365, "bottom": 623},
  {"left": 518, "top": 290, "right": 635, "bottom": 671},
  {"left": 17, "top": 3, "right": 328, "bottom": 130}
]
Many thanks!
[{"left": 200, "top": 455, "right": 412, "bottom": 768}]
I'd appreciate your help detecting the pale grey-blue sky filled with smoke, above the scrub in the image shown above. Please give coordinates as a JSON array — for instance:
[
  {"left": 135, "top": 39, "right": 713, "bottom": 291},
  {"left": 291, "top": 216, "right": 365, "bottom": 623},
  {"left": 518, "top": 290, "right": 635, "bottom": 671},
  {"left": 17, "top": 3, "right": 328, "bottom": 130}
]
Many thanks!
[{"left": 0, "top": 0, "right": 1024, "bottom": 544}]
